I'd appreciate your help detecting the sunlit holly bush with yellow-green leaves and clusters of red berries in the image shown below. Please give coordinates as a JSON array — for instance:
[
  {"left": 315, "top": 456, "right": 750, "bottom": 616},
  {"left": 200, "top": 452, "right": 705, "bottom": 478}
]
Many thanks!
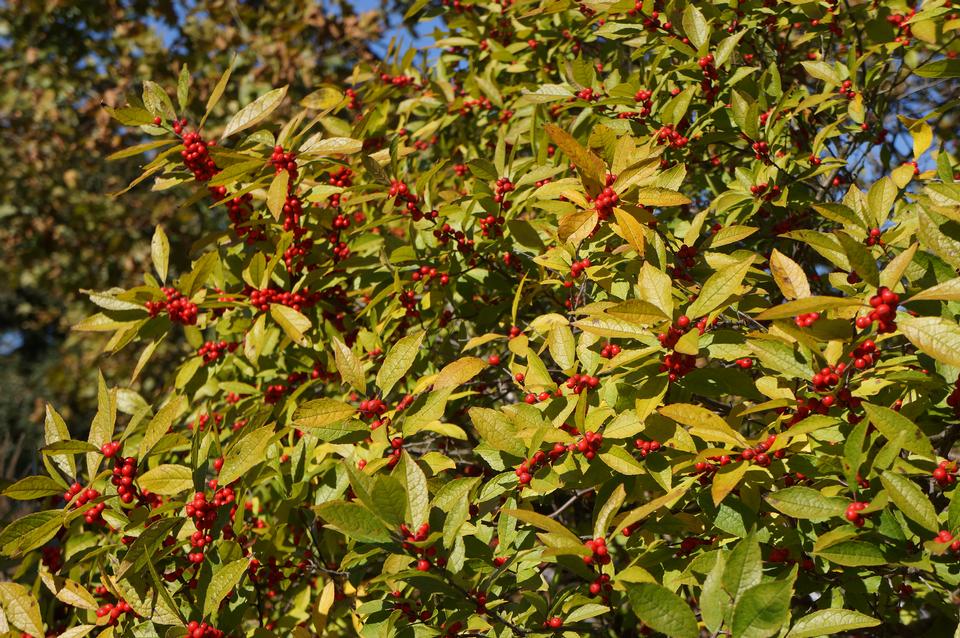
[{"left": 0, "top": 0, "right": 960, "bottom": 638}]
